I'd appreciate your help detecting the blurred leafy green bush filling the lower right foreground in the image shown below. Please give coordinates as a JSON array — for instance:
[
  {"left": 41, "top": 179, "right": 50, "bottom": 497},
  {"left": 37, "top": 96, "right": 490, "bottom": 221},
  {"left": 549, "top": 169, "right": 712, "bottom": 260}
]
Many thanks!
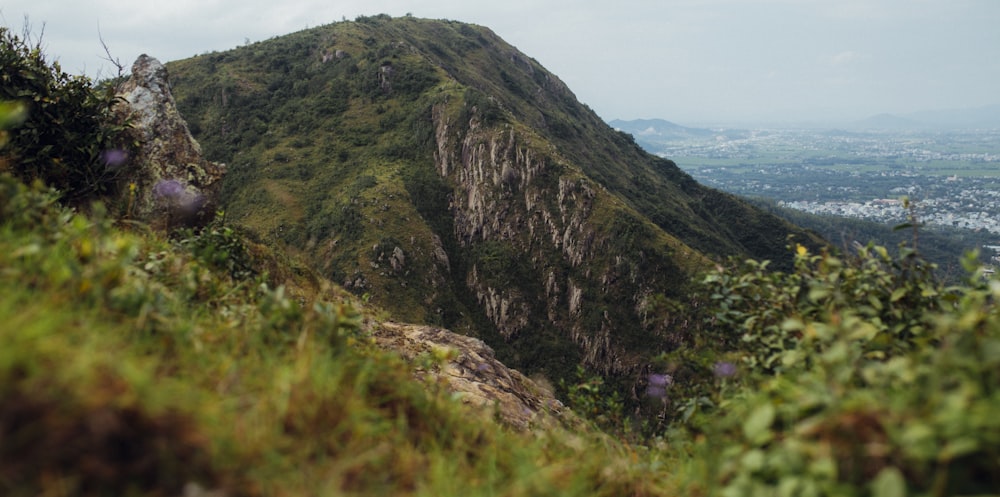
[{"left": 692, "top": 243, "right": 1000, "bottom": 495}]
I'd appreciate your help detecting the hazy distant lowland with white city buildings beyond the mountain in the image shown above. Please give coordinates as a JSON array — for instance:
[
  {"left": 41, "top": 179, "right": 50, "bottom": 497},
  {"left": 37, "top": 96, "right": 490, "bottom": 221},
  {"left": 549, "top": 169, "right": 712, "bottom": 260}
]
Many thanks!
[{"left": 611, "top": 120, "right": 1000, "bottom": 254}]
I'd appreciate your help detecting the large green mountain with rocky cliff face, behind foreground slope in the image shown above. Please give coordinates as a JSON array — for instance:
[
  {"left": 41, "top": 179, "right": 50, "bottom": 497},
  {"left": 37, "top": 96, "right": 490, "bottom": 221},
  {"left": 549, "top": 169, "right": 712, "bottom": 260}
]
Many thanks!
[{"left": 167, "top": 15, "right": 822, "bottom": 379}]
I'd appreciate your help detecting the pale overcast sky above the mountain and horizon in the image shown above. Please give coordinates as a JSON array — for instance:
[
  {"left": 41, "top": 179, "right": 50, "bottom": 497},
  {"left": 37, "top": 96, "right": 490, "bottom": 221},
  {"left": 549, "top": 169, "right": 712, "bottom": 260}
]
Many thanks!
[{"left": 0, "top": 0, "right": 1000, "bottom": 124}]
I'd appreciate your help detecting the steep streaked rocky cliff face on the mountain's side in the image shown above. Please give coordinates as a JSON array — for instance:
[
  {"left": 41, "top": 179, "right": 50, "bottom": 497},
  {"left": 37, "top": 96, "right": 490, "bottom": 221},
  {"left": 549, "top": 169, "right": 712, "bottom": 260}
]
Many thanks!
[{"left": 433, "top": 105, "right": 697, "bottom": 374}]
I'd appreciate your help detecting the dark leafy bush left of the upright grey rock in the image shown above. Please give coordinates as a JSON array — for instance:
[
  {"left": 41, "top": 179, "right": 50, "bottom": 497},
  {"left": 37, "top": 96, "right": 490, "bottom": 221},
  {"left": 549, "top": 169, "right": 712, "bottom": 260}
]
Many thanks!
[{"left": 0, "top": 27, "right": 137, "bottom": 203}]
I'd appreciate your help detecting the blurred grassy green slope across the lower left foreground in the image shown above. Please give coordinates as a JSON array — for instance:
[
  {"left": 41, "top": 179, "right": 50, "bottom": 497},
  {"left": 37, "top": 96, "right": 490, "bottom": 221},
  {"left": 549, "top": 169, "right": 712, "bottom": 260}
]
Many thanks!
[{"left": 0, "top": 177, "right": 688, "bottom": 496}]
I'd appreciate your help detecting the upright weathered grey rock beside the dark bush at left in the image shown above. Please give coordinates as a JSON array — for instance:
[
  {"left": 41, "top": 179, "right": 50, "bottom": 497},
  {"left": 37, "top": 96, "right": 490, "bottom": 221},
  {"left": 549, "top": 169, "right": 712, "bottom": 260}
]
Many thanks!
[{"left": 118, "top": 54, "right": 225, "bottom": 228}]
